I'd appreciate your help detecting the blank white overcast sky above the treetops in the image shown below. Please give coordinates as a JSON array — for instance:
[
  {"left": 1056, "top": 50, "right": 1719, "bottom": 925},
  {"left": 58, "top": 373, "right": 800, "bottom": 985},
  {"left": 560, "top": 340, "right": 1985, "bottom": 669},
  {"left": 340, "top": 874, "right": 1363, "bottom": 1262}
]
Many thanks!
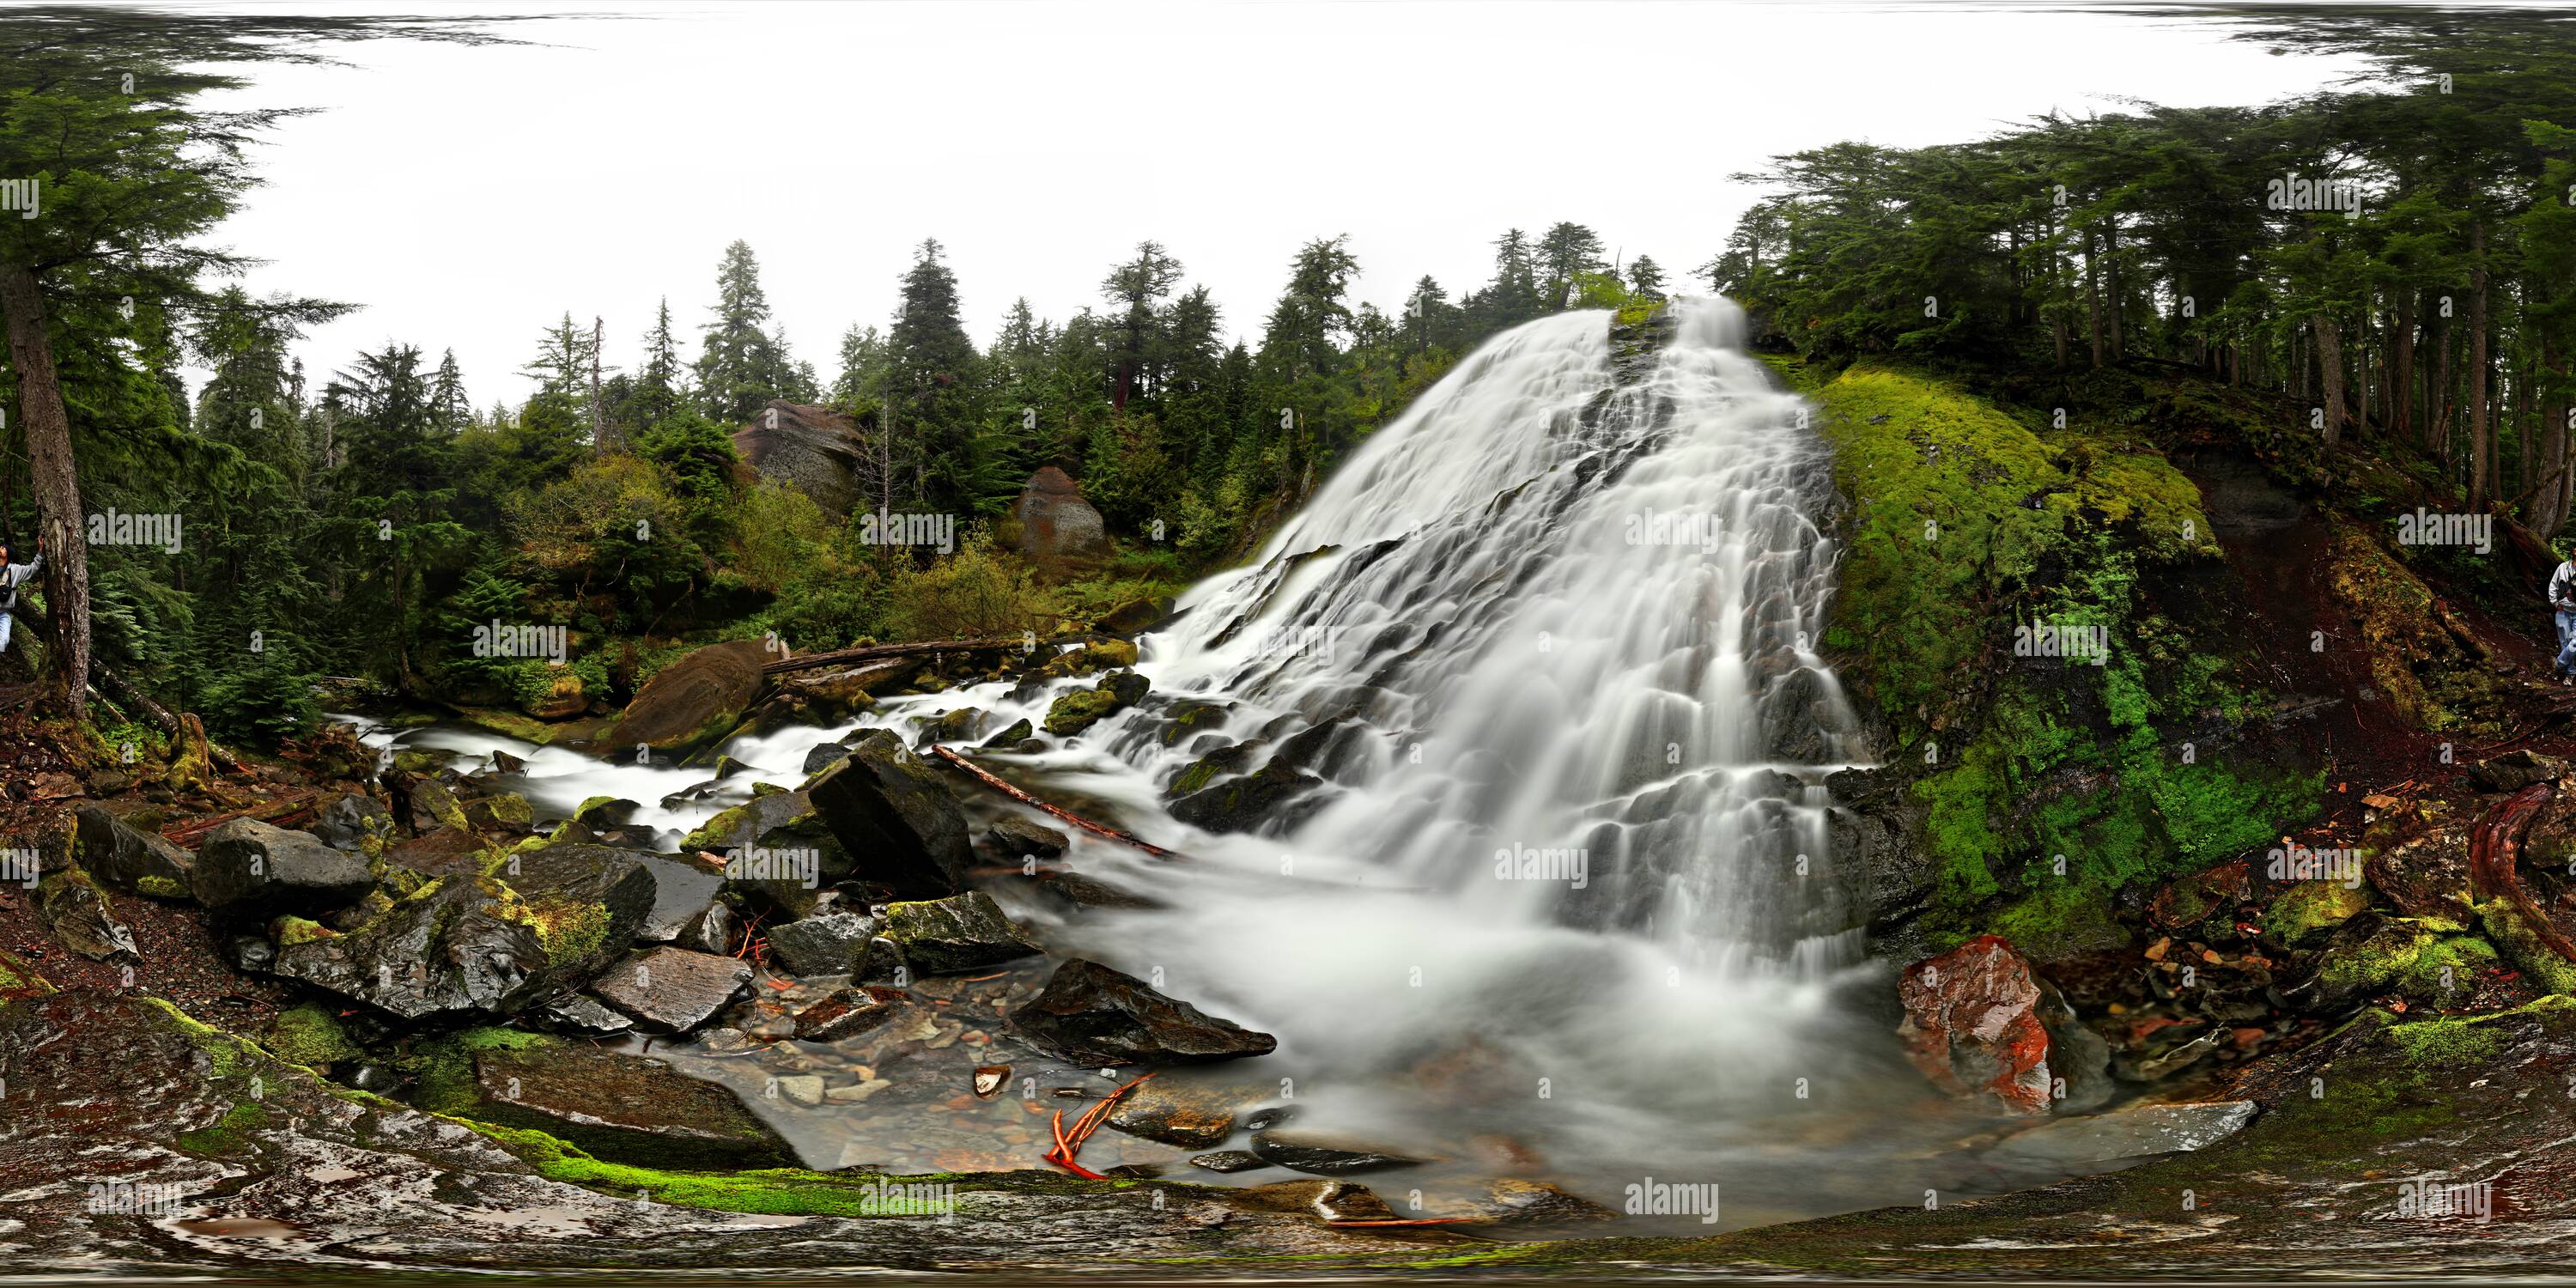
[{"left": 201, "top": 0, "right": 2352, "bottom": 407}]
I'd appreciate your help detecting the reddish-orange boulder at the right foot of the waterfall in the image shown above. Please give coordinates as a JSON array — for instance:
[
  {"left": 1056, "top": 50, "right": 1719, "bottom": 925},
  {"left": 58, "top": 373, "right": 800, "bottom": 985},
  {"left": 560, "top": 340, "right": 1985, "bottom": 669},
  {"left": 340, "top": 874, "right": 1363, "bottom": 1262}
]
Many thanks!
[{"left": 1896, "top": 935, "right": 2110, "bottom": 1113}]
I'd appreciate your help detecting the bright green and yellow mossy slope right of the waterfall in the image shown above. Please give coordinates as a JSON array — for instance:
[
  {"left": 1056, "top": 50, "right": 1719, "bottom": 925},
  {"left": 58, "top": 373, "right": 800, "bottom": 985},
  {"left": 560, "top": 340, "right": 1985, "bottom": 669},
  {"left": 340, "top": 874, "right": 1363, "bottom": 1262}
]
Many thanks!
[{"left": 1775, "top": 363, "right": 2321, "bottom": 945}]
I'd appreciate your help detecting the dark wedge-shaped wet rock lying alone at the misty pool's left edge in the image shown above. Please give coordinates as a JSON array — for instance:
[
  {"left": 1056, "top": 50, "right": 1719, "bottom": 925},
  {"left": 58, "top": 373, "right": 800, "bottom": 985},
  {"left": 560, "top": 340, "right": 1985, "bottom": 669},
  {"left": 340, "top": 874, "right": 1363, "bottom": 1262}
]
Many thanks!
[{"left": 1010, "top": 958, "right": 1278, "bottom": 1066}]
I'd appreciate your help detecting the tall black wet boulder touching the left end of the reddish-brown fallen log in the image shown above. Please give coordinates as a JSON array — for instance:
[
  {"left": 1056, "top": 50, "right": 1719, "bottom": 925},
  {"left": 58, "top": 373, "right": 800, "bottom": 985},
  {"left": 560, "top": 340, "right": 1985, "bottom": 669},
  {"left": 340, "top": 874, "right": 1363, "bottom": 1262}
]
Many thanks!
[{"left": 806, "top": 729, "right": 974, "bottom": 899}]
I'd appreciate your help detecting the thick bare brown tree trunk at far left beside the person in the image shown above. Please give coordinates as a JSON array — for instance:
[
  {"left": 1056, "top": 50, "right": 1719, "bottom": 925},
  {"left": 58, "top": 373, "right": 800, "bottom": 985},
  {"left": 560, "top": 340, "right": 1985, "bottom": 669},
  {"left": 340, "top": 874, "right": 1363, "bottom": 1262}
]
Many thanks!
[{"left": 0, "top": 263, "right": 90, "bottom": 719}]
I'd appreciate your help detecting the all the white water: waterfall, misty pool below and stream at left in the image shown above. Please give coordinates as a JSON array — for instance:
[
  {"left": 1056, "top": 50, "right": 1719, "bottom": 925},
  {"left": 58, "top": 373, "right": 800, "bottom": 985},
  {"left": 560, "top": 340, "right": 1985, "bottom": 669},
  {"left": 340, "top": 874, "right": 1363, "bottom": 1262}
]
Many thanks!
[{"left": 358, "top": 299, "right": 2030, "bottom": 1226}]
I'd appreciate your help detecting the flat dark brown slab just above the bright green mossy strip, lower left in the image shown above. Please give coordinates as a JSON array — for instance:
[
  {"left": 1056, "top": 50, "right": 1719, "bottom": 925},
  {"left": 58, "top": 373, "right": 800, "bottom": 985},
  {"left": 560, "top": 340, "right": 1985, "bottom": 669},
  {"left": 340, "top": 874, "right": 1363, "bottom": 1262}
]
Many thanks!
[{"left": 456, "top": 1030, "right": 796, "bottom": 1170}]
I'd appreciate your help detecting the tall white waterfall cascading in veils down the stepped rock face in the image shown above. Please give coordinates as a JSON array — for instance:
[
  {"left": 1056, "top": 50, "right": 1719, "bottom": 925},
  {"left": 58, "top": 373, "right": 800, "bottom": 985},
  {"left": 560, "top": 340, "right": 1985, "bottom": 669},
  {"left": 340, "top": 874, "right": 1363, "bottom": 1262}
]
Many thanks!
[{"left": 1146, "top": 299, "right": 1857, "bottom": 969}]
